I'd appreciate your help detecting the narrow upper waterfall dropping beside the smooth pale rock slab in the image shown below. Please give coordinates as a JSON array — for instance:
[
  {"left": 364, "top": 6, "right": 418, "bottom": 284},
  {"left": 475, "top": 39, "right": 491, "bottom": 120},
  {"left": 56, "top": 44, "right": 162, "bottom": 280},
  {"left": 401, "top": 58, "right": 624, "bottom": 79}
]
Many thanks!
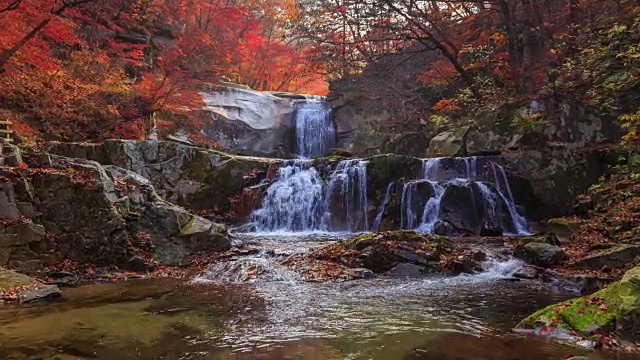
[{"left": 295, "top": 99, "right": 336, "bottom": 158}]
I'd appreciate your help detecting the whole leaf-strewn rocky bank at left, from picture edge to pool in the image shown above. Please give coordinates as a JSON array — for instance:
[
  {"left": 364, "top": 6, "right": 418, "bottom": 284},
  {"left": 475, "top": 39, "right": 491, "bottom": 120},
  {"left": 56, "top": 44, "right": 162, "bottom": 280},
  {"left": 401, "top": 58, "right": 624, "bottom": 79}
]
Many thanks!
[{"left": 0, "top": 148, "right": 236, "bottom": 302}]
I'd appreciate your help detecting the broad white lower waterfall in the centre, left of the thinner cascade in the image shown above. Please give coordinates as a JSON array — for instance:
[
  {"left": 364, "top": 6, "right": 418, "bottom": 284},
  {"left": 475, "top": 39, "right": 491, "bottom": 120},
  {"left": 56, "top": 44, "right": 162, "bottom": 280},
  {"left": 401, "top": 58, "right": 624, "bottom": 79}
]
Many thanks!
[{"left": 251, "top": 159, "right": 369, "bottom": 232}]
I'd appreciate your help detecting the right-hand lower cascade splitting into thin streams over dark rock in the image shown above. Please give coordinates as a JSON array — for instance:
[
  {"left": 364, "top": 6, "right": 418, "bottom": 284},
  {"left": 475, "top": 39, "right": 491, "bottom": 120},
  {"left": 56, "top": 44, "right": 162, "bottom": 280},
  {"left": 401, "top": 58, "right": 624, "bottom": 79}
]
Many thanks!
[{"left": 401, "top": 157, "right": 528, "bottom": 235}]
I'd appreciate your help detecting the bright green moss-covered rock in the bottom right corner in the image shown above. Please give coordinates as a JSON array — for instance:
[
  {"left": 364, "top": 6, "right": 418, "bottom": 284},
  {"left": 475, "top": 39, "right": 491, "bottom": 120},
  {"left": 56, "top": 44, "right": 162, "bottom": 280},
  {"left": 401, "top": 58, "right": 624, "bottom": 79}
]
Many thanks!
[{"left": 517, "top": 266, "right": 640, "bottom": 340}]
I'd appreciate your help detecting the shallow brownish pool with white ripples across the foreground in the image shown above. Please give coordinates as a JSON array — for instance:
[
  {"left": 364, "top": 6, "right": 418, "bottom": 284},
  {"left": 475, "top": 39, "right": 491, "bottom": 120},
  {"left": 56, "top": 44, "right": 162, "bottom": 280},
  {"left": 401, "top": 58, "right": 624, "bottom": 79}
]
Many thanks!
[{"left": 0, "top": 236, "right": 633, "bottom": 360}]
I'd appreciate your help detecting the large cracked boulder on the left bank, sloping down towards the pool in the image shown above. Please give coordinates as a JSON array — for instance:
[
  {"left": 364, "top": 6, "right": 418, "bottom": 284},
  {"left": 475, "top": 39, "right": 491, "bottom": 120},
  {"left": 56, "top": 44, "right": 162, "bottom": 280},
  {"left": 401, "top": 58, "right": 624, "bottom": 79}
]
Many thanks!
[{"left": 0, "top": 154, "right": 230, "bottom": 271}]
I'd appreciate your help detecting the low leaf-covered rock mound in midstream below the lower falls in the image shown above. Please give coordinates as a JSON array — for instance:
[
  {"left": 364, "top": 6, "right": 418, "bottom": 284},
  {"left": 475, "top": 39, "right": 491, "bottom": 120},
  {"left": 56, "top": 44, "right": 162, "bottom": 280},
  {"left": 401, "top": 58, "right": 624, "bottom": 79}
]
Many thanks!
[{"left": 282, "top": 230, "right": 485, "bottom": 281}]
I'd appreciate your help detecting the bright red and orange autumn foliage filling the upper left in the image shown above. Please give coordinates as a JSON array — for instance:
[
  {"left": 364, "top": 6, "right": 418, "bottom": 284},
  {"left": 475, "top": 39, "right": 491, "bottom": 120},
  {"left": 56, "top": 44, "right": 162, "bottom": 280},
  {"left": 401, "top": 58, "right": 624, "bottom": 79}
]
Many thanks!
[{"left": 0, "top": 0, "right": 326, "bottom": 140}]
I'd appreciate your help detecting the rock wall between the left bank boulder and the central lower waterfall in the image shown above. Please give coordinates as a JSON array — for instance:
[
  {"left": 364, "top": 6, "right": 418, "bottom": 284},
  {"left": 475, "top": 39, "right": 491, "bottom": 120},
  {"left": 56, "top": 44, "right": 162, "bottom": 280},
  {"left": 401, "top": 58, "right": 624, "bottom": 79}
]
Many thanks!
[{"left": 47, "top": 140, "right": 273, "bottom": 214}]
